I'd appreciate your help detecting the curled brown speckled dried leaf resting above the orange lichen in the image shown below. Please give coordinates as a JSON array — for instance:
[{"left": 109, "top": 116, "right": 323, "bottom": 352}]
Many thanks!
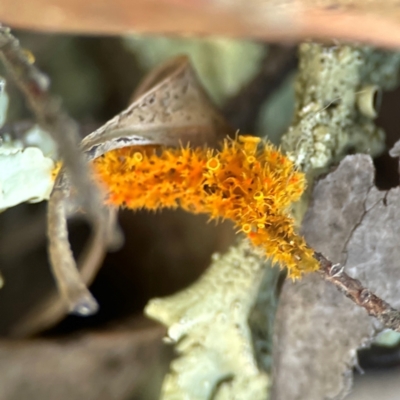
[{"left": 81, "top": 56, "right": 233, "bottom": 160}]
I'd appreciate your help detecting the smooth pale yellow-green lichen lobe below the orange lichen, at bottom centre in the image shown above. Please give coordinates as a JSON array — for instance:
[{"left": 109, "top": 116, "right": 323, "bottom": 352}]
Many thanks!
[{"left": 145, "top": 241, "right": 269, "bottom": 400}]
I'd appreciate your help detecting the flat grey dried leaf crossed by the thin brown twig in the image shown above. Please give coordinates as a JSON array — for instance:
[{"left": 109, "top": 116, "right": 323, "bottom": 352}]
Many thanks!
[{"left": 272, "top": 155, "right": 400, "bottom": 400}]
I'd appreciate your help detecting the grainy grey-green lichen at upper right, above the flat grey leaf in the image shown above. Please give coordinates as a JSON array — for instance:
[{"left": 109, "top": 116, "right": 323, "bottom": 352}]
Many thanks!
[{"left": 282, "top": 43, "right": 400, "bottom": 171}]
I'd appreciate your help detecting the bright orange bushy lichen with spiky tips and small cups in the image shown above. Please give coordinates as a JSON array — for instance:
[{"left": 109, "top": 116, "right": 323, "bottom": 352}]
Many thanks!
[{"left": 93, "top": 136, "right": 318, "bottom": 278}]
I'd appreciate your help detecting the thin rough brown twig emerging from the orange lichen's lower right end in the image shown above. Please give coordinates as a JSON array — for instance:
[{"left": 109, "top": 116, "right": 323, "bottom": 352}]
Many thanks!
[{"left": 314, "top": 252, "right": 400, "bottom": 332}]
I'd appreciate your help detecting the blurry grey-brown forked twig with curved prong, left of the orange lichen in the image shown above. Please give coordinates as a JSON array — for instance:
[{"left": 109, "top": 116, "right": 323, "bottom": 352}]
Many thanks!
[{"left": 0, "top": 25, "right": 121, "bottom": 315}]
